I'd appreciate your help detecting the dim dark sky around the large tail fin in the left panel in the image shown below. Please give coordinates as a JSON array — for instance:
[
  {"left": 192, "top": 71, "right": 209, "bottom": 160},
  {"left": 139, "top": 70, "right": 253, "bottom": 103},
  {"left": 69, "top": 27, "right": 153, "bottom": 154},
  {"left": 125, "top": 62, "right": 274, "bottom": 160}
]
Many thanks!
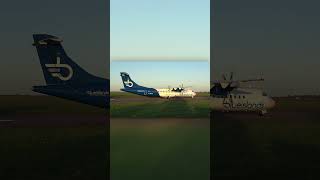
[{"left": 0, "top": 0, "right": 110, "bottom": 94}]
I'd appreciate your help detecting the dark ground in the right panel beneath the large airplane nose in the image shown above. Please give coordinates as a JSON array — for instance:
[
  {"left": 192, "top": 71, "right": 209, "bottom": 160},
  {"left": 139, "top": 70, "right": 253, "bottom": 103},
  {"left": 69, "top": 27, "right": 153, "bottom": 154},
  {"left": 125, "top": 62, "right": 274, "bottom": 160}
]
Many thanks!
[{"left": 211, "top": 97, "right": 320, "bottom": 180}]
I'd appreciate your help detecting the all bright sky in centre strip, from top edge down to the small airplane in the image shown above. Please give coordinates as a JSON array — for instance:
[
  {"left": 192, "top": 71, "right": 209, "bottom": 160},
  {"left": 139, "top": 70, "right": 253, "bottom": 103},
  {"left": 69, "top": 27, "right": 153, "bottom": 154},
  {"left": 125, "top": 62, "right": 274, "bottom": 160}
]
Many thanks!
[{"left": 110, "top": 0, "right": 210, "bottom": 92}]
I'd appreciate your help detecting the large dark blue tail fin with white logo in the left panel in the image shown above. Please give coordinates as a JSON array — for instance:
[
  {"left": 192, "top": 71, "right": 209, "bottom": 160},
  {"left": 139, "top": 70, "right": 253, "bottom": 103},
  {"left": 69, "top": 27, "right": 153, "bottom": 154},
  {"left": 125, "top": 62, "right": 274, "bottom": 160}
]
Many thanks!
[{"left": 33, "top": 34, "right": 95, "bottom": 85}]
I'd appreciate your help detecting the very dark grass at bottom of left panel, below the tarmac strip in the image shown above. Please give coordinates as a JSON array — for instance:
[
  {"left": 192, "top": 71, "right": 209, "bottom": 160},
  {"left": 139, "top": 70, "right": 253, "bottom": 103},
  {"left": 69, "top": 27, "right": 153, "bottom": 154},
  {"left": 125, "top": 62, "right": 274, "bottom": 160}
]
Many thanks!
[{"left": 0, "top": 127, "right": 107, "bottom": 180}]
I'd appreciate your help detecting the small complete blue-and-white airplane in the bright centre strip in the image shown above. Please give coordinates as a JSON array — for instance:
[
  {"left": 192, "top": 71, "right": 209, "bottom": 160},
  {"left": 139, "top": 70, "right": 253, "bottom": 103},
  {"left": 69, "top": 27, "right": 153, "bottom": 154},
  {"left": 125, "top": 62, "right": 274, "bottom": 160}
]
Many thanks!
[{"left": 120, "top": 72, "right": 196, "bottom": 99}]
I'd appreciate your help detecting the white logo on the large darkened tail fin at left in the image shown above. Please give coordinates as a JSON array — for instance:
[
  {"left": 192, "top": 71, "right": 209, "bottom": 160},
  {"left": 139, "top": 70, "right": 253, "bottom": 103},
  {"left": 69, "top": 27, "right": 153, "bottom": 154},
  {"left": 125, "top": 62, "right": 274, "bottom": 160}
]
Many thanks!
[{"left": 45, "top": 57, "right": 73, "bottom": 81}]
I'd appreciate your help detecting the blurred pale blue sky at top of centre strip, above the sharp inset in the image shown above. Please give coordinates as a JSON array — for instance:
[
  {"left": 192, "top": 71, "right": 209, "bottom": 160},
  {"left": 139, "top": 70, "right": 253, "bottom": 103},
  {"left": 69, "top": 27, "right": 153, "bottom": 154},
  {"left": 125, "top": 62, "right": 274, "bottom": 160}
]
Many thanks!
[{"left": 110, "top": 0, "right": 210, "bottom": 60}]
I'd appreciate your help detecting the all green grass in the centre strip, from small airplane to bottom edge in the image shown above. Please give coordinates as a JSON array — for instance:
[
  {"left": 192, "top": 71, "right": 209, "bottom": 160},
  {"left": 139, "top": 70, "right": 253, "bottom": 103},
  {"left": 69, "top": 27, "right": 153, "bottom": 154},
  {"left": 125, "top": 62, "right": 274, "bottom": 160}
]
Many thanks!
[{"left": 110, "top": 92, "right": 210, "bottom": 180}]
